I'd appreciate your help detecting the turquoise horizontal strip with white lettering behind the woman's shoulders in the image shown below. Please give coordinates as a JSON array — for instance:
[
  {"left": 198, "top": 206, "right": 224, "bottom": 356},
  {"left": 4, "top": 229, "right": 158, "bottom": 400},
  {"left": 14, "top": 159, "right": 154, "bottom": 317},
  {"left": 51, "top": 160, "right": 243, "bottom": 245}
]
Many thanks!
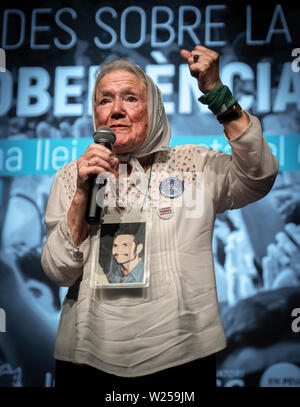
[{"left": 0, "top": 134, "right": 300, "bottom": 176}]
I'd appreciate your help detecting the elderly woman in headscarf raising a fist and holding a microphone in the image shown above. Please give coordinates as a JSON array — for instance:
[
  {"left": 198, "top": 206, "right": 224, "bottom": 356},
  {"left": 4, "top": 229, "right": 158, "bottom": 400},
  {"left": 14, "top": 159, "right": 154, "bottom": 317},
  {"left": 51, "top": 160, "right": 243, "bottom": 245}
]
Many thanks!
[{"left": 42, "top": 46, "right": 278, "bottom": 390}]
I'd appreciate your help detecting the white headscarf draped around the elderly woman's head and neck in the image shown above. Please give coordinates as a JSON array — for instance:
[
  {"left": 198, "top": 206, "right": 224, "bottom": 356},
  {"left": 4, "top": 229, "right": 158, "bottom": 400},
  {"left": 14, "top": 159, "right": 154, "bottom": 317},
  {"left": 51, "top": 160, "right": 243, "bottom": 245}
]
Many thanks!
[{"left": 92, "top": 63, "right": 171, "bottom": 169}]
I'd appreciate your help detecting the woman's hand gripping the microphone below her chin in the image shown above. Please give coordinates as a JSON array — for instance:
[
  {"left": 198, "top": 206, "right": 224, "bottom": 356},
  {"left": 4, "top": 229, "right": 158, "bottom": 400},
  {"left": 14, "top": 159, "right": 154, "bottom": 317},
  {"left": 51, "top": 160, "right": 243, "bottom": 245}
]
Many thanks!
[{"left": 77, "top": 143, "right": 119, "bottom": 194}]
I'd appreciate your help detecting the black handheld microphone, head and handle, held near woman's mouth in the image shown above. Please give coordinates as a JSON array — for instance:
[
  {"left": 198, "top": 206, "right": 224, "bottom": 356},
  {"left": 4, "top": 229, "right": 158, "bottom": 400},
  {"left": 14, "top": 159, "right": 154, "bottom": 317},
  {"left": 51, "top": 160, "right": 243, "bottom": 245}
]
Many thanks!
[{"left": 85, "top": 126, "right": 116, "bottom": 225}]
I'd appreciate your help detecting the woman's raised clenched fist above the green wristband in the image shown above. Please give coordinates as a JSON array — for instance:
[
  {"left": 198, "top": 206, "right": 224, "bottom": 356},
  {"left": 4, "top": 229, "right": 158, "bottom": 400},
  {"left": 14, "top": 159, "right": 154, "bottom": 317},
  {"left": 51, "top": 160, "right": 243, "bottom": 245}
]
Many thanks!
[{"left": 180, "top": 45, "right": 222, "bottom": 93}]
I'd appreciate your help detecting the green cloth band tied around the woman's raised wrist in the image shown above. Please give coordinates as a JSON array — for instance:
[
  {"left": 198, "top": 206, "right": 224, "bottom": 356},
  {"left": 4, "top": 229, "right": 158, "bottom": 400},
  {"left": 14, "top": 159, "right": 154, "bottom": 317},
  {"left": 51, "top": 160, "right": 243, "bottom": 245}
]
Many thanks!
[{"left": 198, "top": 84, "right": 237, "bottom": 115}]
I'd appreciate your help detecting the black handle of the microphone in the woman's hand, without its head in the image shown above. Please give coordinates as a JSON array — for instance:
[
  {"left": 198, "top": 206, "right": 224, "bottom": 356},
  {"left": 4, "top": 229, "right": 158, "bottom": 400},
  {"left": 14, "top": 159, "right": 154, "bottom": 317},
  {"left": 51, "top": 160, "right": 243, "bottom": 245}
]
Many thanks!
[{"left": 85, "top": 143, "right": 112, "bottom": 226}]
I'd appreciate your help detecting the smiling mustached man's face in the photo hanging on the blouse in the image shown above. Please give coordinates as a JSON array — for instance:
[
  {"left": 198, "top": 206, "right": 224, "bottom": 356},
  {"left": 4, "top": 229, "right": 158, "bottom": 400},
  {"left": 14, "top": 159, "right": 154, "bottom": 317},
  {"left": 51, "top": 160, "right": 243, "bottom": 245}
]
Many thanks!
[{"left": 112, "top": 235, "right": 142, "bottom": 264}]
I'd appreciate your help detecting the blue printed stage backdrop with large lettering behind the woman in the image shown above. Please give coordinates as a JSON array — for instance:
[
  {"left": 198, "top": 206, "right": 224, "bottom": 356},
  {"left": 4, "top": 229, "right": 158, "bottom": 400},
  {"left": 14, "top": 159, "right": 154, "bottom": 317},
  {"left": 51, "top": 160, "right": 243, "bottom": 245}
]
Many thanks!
[{"left": 0, "top": 0, "right": 300, "bottom": 387}]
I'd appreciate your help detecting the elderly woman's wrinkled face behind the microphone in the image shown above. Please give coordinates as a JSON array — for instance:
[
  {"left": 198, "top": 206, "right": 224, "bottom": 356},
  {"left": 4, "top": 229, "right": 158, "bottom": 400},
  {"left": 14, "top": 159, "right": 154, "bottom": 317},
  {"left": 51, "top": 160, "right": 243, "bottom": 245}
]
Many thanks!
[{"left": 95, "top": 70, "right": 148, "bottom": 154}]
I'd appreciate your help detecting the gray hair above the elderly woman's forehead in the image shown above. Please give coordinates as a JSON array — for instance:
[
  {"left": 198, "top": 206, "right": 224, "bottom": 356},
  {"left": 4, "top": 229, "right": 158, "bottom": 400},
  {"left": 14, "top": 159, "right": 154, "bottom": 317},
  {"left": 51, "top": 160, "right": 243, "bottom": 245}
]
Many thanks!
[{"left": 92, "top": 59, "right": 148, "bottom": 112}]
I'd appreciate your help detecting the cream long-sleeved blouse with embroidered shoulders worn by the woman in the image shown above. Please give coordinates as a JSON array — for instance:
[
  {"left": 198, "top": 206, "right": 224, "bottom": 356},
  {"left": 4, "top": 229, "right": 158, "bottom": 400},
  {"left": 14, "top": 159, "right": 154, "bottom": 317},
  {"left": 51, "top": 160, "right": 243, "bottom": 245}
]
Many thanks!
[{"left": 42, "top": 116, "right": 278, "bottom": 377}]
